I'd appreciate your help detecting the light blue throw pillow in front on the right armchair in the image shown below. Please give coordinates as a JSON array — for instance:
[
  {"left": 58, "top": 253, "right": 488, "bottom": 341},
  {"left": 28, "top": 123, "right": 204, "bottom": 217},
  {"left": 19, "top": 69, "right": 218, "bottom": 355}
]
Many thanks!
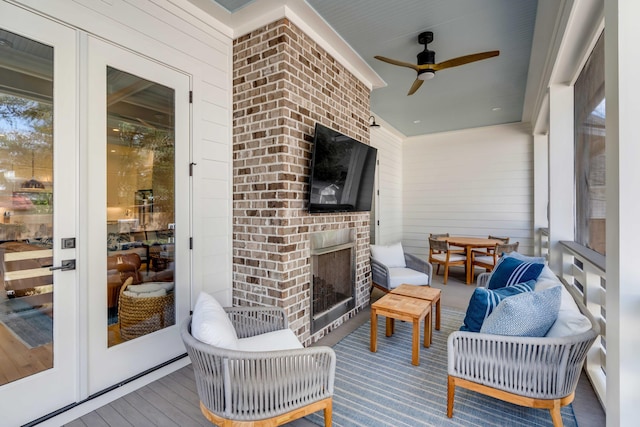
[{"left": 480, "top": 286, "right": 562, "bottom": 337}]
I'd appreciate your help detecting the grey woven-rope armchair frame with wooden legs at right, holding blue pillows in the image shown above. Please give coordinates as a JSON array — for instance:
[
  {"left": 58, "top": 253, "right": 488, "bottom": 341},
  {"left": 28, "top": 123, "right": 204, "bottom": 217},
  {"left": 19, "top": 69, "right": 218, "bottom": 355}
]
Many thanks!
[{"left": 447, "top": 273, "right": 599, "bottom": 426}]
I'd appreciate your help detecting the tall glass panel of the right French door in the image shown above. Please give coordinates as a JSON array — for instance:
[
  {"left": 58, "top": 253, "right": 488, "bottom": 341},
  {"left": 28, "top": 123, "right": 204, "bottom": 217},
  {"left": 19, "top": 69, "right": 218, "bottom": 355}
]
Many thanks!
[{"left": 106, "top": 67, "right": 175, "bottom": 347}]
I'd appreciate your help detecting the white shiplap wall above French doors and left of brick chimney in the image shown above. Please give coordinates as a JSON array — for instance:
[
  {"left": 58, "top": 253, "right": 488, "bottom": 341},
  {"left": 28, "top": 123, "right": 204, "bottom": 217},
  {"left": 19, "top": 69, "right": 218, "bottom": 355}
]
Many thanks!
[{"left": 18, "top": 0, "right": 232, "bottom": 305}]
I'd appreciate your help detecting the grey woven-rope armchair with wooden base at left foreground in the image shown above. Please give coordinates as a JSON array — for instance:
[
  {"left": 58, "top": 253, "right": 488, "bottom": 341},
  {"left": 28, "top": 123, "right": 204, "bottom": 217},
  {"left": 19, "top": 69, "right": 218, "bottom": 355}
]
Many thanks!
[{"left": 180, "top": 307, "right": 336, "bottom": 427}]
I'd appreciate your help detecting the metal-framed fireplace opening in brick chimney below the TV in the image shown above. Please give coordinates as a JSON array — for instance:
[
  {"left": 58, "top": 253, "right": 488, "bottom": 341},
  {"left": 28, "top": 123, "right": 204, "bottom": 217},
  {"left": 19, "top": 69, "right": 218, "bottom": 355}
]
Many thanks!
[{"left": 311, "top": 230, "right": 355, "bottom": 333}]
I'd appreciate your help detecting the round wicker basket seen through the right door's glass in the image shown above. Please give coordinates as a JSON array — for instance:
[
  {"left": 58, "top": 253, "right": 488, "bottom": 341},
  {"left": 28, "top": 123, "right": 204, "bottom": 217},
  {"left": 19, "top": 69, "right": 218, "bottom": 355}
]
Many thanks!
[{"left": 118, "top": 286, "right": 176, "bottom": 340}]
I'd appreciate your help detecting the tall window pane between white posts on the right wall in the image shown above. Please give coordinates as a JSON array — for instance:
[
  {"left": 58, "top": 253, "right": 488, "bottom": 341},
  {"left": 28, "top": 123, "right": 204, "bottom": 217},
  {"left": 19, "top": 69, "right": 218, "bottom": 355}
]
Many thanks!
[{"left": 575, "top": 35, "right": 606, "bottom": 255}]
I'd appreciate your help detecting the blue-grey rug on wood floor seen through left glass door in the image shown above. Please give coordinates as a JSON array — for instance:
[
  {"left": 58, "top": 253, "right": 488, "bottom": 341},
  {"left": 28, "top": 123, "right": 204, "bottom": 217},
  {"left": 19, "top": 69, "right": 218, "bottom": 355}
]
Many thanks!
[{"left": 0, "top": 299, "right": 53, "bottom": 348}]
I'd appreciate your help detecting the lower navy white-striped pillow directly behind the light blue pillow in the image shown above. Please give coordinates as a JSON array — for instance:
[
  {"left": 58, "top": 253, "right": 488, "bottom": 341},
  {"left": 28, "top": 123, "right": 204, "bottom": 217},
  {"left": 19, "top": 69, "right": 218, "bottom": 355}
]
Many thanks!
[{"left": 460, "top": 280, "right": 536, "bottom": 332}]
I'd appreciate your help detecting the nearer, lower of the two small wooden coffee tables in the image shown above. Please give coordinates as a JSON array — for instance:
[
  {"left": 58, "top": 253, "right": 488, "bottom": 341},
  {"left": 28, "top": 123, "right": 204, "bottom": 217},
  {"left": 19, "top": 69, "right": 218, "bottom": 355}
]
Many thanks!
[{"left": 370, "top": 293, "right": 431, "bottom": 366}]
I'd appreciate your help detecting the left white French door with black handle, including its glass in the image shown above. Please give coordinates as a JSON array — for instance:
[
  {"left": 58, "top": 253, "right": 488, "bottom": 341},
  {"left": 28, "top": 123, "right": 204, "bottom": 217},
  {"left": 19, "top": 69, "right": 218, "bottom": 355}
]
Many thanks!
[{"left": 0, "top": 2, "right": 79, "bottom": 425}]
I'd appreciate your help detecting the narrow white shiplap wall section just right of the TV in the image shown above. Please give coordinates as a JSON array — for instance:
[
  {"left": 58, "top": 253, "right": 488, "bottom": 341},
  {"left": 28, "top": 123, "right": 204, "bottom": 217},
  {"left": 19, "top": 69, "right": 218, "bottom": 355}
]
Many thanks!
[{"left": 370, "top": 127, "right": 402, "bottom": 244}]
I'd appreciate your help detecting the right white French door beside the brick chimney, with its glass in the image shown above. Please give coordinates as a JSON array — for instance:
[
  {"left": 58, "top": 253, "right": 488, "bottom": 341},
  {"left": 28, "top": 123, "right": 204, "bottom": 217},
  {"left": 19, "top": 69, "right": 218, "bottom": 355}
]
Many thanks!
[{"left": 83, "top": 37, "right": 190, "bottom": 394}]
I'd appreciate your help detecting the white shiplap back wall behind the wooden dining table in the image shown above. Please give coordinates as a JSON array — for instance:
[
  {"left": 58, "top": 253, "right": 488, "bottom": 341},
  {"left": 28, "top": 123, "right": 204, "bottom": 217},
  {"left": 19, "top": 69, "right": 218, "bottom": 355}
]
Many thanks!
[{"left": 402, "top": 124, "right": 534, "bottom": 256}]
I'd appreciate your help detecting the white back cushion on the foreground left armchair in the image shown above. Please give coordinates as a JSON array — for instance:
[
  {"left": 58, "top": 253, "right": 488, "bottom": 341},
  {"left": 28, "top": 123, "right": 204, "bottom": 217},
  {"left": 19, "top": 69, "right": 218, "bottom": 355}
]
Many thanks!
[{"left": 191, "top": 292, "right": 238, "bottom": 350}]
